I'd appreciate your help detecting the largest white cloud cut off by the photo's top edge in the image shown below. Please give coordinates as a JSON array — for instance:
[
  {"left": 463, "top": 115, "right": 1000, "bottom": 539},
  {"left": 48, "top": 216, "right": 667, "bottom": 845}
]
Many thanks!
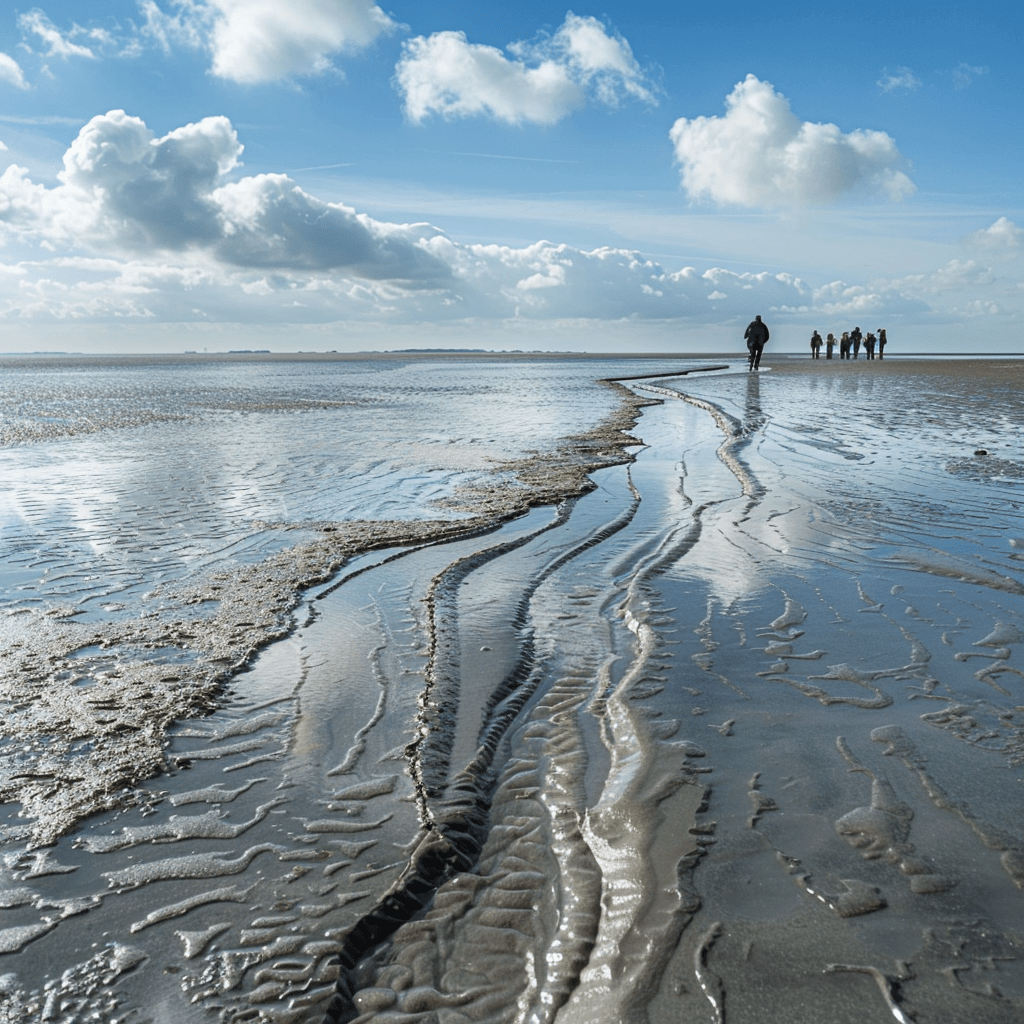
[{"left": 139, "top": 0, "right": 395, "bottom": 84}]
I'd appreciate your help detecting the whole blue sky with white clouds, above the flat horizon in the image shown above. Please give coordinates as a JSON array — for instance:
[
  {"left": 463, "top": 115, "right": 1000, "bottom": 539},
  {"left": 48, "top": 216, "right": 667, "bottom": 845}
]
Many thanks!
[{"left": 0, "top": 0, "right": 1024, "bottom": 354}]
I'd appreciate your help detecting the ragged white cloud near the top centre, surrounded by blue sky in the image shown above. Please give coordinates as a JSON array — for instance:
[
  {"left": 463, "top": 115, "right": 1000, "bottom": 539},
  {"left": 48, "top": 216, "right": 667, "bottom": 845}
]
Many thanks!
[{"left": 395, "top": 11, "right": 654, "bottom": 124}]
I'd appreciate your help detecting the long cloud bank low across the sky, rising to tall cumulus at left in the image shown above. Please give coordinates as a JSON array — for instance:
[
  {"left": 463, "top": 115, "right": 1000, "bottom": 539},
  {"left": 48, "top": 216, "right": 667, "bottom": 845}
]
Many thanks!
[{"left": 0, "top": 111, "right": 1011, "bottom": 324}]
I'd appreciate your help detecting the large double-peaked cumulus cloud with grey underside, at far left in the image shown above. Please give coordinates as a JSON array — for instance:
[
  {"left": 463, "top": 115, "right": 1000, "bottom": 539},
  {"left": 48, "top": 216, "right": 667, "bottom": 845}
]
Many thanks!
[{"left": 0, "top": 111, "right": 447, "bottom": 283}]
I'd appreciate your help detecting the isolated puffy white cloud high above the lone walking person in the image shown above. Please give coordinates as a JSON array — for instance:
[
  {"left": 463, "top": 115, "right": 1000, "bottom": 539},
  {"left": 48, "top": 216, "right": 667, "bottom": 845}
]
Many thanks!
[{"left": 670, "top": 75, "right": 914, "bottom": 207}]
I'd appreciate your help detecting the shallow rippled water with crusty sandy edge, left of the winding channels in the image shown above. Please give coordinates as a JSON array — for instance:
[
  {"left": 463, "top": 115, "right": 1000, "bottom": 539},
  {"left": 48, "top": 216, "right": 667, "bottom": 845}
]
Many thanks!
[{"left": 0, "top": 357, "right": 678, "bottom": 841}]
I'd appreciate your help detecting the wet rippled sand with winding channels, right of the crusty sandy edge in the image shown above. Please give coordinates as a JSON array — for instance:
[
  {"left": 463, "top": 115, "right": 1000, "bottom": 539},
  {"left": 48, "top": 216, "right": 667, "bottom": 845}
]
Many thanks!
[{"left": 0, "top": 356, "right": 1024, "bottom": 1024}]
